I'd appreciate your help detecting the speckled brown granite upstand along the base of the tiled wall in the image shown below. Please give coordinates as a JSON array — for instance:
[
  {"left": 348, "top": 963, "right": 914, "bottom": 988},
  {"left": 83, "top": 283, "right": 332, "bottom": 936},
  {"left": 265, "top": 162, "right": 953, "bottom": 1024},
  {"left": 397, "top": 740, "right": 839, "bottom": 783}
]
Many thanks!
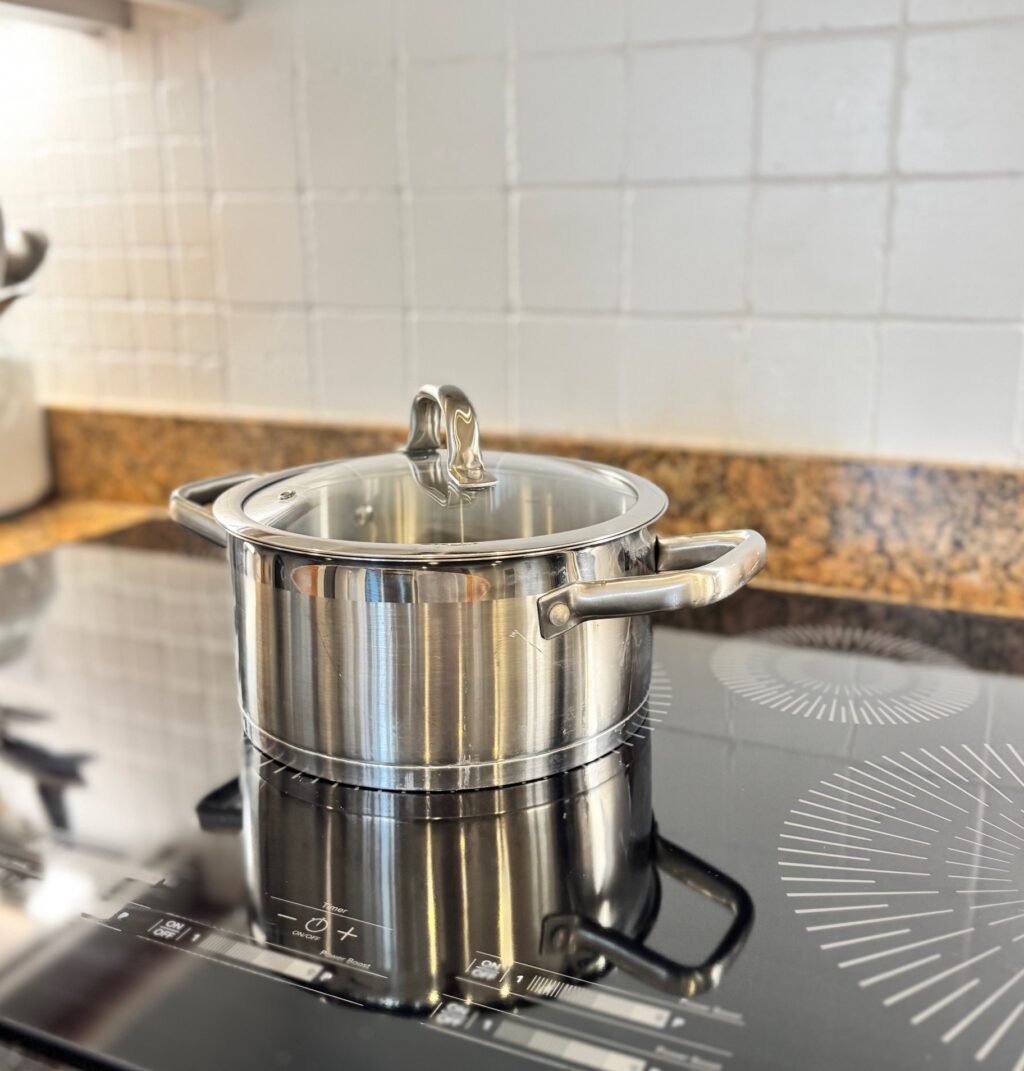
[{"left": 50, "top": 409, "right": 1024, "bottom": 614}]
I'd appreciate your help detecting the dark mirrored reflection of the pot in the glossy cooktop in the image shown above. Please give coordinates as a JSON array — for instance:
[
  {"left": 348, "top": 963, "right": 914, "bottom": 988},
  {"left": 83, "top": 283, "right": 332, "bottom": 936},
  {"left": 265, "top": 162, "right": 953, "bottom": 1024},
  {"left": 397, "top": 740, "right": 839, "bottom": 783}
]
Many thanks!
[{"left": 199, "top": 742, "right": 753, "bottom": 1012}]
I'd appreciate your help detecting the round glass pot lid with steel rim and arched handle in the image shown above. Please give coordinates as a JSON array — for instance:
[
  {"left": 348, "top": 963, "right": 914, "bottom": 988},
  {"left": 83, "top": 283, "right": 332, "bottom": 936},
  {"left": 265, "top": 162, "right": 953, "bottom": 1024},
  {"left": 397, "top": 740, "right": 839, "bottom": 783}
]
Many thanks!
[{"left": 214, "top": 387, "right": 667, "bottom": 559}]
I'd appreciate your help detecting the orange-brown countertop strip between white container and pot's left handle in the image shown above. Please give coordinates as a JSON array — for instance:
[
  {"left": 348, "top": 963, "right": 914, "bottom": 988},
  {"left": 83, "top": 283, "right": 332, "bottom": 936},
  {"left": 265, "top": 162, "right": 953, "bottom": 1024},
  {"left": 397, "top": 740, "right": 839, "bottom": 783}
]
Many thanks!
[{"left": 0, "top": 498, "right": 167, "bottom": 563}]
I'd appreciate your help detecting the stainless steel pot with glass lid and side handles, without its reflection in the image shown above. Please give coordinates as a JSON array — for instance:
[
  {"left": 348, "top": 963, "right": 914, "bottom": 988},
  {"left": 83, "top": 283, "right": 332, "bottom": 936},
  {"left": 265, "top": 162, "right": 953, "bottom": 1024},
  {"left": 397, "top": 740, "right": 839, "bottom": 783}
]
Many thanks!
[{"left": 170, "top": 387, "right": 765, "bottom": 790}]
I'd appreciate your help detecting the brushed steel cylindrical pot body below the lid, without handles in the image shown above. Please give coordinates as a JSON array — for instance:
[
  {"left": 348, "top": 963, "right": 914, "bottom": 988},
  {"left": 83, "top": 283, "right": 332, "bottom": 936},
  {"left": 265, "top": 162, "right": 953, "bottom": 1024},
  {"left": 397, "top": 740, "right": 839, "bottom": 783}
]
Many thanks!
[{"left": 228, "top": 529, "right": 657, "bottom": 790}]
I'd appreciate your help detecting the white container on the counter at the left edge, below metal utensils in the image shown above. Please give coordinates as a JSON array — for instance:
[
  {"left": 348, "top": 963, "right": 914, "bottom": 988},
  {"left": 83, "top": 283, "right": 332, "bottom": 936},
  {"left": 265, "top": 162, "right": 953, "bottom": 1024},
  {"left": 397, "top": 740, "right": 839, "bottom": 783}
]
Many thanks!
[{"left": 0, "top": 326, "right": 51, "bottom": 517}]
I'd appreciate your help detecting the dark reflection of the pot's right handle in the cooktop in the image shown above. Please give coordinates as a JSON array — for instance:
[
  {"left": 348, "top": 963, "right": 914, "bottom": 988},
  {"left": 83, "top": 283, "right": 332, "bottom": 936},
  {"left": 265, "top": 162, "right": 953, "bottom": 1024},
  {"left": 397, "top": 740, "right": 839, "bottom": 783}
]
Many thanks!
[{"left": 541, "top": 830, "right": 754, "bottom": 997}]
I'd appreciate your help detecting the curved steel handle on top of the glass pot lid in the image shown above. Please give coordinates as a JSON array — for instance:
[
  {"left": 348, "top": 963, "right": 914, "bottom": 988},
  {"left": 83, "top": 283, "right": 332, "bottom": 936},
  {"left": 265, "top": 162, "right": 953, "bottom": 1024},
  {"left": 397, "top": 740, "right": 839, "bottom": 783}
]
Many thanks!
[{"left": 405, "top": 383, "right": 498, "bottom": 491}]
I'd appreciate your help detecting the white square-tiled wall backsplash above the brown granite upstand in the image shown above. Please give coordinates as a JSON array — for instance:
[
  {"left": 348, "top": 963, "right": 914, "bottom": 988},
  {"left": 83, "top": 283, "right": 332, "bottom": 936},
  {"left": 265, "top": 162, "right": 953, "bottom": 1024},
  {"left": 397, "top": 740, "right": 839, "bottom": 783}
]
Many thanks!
[{"left": 0, "top": 0, "right": 1024, "bottom": 465}]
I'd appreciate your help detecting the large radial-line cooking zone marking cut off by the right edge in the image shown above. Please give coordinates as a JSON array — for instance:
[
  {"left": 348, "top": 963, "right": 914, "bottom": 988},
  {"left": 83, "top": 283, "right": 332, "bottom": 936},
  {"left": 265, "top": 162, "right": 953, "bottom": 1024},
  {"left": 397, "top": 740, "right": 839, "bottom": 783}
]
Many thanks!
[{"left": 779, "top": 742, "right": 1024, "bottom": 1071}]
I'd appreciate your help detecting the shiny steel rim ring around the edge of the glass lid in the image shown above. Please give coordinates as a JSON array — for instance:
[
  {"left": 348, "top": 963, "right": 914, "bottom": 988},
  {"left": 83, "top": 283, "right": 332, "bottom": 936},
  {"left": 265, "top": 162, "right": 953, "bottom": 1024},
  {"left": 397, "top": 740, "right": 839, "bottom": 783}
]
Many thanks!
[{"left": 213, "top": 454, "right": 668, "bottom": 564}]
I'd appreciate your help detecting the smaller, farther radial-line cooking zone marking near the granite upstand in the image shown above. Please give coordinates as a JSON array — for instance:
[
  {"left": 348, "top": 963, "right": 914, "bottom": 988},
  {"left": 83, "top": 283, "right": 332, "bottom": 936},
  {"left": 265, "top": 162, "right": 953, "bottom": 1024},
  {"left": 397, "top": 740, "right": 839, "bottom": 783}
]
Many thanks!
[{"left": 711, "top": 624, "right": 978, "bottom": 725}]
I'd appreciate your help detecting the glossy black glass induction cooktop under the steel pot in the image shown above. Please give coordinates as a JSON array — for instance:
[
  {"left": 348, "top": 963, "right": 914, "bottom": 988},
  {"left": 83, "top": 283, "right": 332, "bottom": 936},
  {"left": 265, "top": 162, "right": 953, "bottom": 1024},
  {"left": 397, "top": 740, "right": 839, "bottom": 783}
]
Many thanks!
[{"left": 0, "top": 524, "right": 1024, "bottom": 1071}]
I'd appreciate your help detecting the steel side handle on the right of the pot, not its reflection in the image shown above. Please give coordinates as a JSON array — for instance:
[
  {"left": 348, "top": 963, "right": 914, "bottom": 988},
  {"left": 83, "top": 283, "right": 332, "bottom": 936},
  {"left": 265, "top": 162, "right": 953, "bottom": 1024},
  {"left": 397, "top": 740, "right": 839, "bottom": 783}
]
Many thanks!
[{"left": 537, "top": 528, "right": 767, "bottom": 639}]
